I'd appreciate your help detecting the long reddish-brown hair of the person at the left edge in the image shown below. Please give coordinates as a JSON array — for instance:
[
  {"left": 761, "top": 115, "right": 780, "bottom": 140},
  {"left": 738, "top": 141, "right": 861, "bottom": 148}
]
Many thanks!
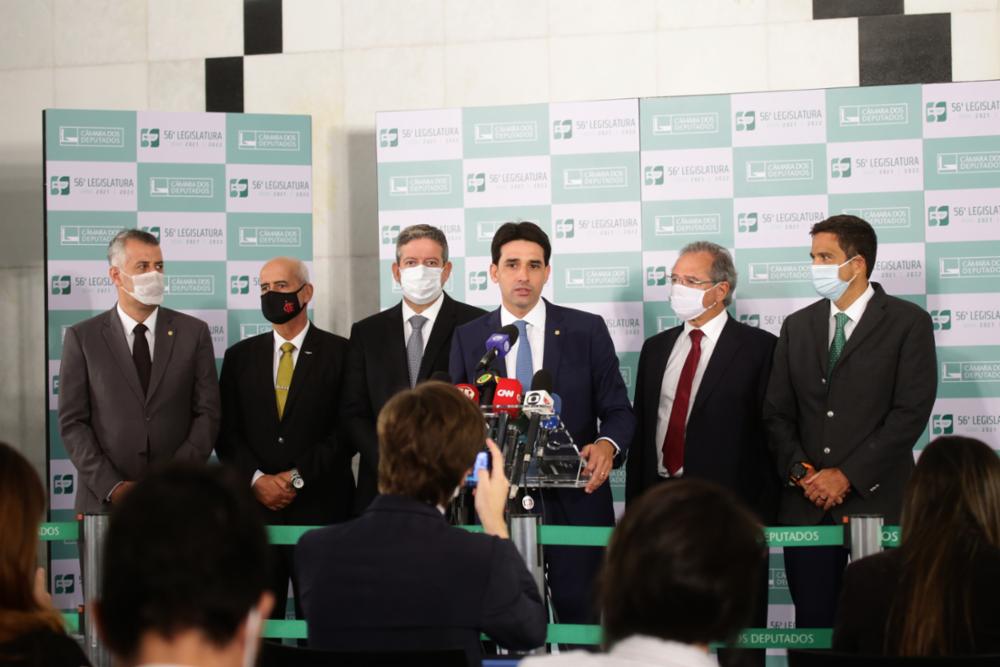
[{"left": 0, "top": 442, "right": 63, "bottom": 642}]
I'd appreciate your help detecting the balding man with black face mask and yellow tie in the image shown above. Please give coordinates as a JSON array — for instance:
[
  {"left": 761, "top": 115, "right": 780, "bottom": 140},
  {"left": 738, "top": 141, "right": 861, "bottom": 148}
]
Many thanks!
[{"left": 216, "top": 257, "right": 354, "bottom": 619}]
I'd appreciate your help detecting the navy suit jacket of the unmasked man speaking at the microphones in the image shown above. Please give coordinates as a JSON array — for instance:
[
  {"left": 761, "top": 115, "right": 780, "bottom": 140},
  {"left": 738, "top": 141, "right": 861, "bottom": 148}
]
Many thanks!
[{"left": 449, "top": 301, "right": 635, "bottom": 525}]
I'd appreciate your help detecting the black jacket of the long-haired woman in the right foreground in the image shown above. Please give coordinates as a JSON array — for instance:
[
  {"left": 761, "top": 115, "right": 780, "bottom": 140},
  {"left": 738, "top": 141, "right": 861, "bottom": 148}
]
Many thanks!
[{"left": 833, "top": 548, "right": 1000, "bottom": 655}]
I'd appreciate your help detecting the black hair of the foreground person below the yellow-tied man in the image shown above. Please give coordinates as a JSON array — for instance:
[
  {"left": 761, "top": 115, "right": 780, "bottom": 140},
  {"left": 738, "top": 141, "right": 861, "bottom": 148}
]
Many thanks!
[{"left": 99, "top": 464, "right": 271, "bottom": 659}]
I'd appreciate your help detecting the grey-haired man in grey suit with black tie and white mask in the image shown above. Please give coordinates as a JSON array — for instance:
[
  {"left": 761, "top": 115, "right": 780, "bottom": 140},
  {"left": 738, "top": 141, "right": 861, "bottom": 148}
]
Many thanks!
[{"left": 59, "top": 229, "right": 220, "bottom": 514}]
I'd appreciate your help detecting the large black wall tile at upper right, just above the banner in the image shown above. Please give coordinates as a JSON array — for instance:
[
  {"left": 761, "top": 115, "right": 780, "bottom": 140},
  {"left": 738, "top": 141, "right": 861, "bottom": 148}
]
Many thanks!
[{"left": 858, "top": 14, "right": 951, "bottom": 86}]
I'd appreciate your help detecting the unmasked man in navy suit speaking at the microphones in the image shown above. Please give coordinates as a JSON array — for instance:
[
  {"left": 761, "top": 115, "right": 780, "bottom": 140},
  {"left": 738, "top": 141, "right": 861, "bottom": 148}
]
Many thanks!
[{"left": 450, "top": 222, "right": 635, "bottom": 623}]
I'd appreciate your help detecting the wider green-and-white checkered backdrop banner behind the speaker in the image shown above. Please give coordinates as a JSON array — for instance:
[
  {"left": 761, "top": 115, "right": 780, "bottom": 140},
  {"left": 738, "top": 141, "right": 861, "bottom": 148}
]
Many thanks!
[{"left": 377, "top": 81, "right": 1000, "bottom": 626}]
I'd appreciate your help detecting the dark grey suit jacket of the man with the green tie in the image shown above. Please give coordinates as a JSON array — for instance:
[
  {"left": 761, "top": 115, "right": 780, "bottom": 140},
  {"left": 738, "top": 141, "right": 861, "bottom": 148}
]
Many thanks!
[{"left": 764, "top": 283, "right": 937, "bottom": 525}]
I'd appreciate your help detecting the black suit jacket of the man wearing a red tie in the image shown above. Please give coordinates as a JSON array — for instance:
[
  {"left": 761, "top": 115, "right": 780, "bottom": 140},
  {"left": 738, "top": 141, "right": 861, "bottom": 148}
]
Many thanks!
[{"left": 625, "top": 317, "right": 778, "bottom": 523}]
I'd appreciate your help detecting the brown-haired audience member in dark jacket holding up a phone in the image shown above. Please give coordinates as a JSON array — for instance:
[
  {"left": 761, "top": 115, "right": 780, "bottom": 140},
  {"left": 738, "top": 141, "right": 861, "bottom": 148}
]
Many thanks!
[{"left": 295, "top": 382, "right": 546, "bottom": 665}]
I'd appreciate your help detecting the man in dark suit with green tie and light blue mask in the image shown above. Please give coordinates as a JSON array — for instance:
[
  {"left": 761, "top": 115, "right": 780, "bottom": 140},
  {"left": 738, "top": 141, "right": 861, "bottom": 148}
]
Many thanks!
[{"left": 764, "top": 215, "right": 937, "bottom": 628}]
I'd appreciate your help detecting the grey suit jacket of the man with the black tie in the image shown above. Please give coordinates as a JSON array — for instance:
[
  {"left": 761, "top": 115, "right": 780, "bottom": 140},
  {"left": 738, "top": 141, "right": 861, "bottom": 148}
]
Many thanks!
[{"left": 59, "top": 307, "right": 221, "bottom": 514}]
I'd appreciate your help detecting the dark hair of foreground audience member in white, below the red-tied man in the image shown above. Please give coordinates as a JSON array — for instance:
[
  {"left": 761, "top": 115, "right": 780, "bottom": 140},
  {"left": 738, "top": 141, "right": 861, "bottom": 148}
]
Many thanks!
[{"left": 600, "top": 480, "right": 767, "bottom": 647}]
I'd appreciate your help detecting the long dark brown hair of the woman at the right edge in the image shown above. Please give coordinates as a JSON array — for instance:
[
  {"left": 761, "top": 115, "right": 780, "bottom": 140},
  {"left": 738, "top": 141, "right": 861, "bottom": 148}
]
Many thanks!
[{"left": 885, "top": 436, "right": 1000, "bottom": 656}]
